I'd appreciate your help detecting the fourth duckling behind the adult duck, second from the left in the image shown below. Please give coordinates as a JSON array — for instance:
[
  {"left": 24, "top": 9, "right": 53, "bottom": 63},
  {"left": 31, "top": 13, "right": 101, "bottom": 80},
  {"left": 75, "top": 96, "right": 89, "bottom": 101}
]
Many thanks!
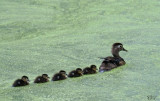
[{"left": 34, "top": 74, "right": 49, "bottom": 83}]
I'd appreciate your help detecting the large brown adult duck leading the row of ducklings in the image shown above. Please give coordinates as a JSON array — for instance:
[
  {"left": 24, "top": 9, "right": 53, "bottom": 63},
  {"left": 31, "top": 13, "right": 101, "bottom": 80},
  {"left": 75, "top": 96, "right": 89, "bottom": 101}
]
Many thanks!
[{"left": 99, "top": 43, "right": 128, "bottom": 72}]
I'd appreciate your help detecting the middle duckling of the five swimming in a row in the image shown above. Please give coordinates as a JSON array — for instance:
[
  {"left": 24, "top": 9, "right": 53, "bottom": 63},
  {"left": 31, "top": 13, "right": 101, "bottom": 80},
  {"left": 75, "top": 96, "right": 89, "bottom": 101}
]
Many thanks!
[{"left": 52, "top": 70, "right": 67, "bottom": 81}]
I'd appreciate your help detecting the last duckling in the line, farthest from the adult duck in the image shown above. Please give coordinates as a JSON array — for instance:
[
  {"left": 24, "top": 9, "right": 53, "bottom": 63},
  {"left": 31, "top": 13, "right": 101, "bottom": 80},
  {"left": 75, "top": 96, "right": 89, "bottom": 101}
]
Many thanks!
[{"left": 12, "top": 76, "right": 29, "bottom": 87}]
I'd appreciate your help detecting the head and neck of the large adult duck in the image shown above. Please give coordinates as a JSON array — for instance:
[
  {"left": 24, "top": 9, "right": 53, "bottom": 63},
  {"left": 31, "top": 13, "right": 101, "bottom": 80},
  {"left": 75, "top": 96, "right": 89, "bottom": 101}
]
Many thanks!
[{"left": 112, "top": 43, "right": 127, "bottom": 57}]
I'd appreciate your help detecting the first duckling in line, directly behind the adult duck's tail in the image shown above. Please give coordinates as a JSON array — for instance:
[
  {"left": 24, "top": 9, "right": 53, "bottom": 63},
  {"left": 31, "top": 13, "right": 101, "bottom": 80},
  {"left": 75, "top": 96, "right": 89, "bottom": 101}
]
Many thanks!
[{"left": 83, "top": 65, "right": 97, "bottom": 75}]
